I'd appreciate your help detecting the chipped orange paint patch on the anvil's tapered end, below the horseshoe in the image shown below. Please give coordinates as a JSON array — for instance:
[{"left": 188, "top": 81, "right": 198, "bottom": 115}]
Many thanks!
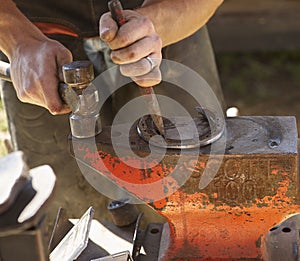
[{"left": 81, "top": 147, "right": 178, "bottom": 201}]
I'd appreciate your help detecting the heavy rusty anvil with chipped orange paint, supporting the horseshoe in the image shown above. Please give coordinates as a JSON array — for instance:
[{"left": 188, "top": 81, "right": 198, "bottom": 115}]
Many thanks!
[{"left": 71, "top": 116, "right": 300, "bottom": 261}]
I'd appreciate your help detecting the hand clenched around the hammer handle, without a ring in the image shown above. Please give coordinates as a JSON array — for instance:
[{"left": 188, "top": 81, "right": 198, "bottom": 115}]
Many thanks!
[{"left": 10, "top": 37, "right": 72, "bottom": 114}]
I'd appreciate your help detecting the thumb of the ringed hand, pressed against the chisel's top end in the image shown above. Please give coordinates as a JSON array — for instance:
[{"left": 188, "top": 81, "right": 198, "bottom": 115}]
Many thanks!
[{"left": 99, "top": 13, "right": 118, "bottom": 42}]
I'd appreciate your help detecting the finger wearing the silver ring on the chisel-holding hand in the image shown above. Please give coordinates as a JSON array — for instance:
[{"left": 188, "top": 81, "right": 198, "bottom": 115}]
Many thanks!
[{"left": 120, "top": 53, "right": 161, "bottom": 77}]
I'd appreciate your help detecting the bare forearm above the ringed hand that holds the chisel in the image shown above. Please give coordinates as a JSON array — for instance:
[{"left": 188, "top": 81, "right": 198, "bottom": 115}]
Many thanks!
[{"left": 137, "top": 0, "right": 223, "bottom": 46}]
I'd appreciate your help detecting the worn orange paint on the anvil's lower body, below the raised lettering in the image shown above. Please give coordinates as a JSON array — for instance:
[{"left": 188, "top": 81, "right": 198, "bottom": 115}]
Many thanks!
[{"left": 159, "top": 158, "right": 300, "bottom": 260}]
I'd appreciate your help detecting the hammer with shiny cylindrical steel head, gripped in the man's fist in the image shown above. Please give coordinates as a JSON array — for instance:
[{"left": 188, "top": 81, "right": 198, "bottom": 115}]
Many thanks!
[{"left": 0, "top": 61, "right": 102, "bottom": 138}]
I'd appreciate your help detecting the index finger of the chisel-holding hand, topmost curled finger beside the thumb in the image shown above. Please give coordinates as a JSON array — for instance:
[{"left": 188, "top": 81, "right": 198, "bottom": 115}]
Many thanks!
[{"left": 108, "top": 10, "right": 155, "bottom": 50}]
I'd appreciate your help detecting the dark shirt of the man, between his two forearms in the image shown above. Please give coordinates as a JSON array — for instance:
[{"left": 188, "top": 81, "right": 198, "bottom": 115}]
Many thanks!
[{"left": 14, "top": 0, "right": 143, "bottom": 38}]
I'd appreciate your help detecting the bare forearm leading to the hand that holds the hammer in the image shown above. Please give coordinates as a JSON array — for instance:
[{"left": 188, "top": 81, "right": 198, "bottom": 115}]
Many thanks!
[{"left": 0, "top": 0, "right": 45, "bottom": 59}]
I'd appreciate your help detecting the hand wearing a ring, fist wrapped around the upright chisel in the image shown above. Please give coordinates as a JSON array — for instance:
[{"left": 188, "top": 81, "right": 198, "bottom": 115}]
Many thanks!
[{"left": 99, "top": 10, "right": 162, "bottom": 87}]
